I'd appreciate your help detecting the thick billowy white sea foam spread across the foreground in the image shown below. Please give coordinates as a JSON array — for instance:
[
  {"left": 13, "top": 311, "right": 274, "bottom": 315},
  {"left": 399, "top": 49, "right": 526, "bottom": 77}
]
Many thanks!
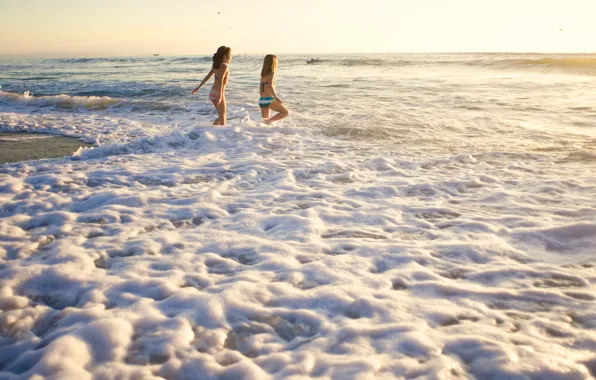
[{"left": 0, "top": 114, "right": 596, "bottom": 379}]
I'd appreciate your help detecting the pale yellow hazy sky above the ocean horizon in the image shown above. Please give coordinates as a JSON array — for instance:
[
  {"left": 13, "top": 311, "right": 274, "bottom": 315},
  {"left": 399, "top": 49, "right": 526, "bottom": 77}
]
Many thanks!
[{"left": 0, "top": 0, "right": 596, "bottom": 56}]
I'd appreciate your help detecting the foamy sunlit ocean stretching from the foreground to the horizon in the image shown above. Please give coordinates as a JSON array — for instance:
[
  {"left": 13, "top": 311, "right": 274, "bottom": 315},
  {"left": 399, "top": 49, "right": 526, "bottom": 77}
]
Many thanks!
[{"left": 0, "top": 53, "right": 596, "bottom": 379}]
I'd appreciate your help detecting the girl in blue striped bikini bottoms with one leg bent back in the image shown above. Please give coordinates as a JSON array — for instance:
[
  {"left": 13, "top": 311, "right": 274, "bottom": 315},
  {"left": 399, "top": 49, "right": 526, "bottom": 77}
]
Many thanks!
[{"left": 259, "top": 54, "right": 290, "bottom": 124}]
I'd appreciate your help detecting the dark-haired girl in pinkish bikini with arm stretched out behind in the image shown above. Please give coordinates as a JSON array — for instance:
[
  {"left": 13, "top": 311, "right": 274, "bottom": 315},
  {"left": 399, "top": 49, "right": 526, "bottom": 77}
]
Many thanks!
[{"left": 192, "top": 46, "right": 232, "bottom": 125}]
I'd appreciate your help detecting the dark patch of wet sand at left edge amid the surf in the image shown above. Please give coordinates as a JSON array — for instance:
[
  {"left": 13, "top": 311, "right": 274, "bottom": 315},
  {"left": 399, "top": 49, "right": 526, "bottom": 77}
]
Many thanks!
[{"left": 0, "top": 132, "right": 93, "bottom": 164}]
